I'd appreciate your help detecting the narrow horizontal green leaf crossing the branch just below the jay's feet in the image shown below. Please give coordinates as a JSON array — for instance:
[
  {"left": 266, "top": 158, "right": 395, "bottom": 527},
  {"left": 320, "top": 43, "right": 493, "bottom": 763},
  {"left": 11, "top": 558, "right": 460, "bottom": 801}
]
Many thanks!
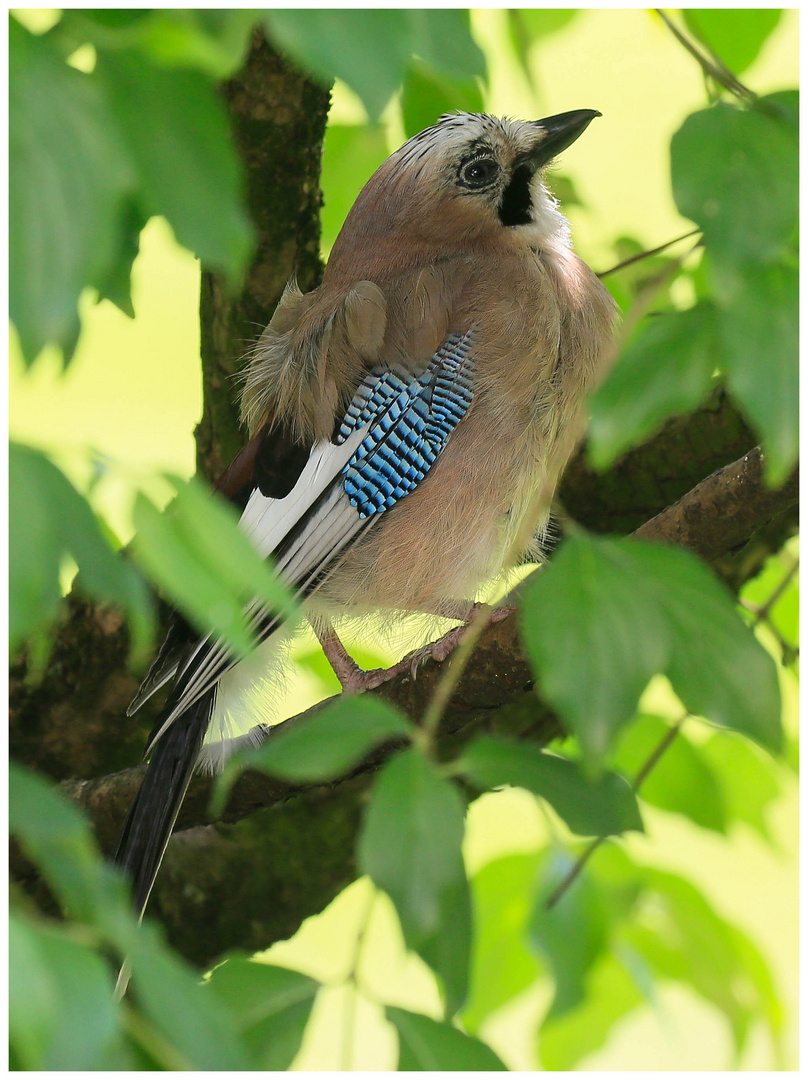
[{"left": 221, "top": 696, "right": 413, "bottom": 783}]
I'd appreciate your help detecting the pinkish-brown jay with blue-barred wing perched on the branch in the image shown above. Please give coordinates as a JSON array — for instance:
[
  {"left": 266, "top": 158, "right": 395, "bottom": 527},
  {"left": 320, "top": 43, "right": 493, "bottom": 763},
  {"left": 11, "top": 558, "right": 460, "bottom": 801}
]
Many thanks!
[{"left": 113, "top": 109, "right": 616, "bottom": 928}]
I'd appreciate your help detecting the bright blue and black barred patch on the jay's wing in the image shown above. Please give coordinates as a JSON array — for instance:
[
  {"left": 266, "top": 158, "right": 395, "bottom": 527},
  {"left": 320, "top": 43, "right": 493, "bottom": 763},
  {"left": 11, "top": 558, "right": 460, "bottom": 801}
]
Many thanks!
[{"left": 337, "top": 329, "right": 474, "bottom": 517}]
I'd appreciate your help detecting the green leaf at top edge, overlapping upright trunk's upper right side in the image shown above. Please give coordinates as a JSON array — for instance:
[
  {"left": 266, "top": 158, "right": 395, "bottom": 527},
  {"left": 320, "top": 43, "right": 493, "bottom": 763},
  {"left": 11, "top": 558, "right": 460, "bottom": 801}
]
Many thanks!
[{"left": 262, "top": 8, "right": 413, "bottom": 120}]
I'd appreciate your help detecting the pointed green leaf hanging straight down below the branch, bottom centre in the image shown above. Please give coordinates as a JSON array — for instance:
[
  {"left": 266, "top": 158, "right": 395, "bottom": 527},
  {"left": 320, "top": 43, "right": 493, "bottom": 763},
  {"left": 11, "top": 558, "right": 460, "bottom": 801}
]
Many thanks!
[{"left": 358, "top": 750, "right": 471, "bottom": 1013}]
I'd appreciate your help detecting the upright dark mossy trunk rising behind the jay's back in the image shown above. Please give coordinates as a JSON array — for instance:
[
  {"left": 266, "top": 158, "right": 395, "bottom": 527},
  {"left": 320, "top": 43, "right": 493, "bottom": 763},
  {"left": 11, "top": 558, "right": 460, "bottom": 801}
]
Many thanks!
[{"left": 196, "top": 30, "right": 329, "bottom": 481}]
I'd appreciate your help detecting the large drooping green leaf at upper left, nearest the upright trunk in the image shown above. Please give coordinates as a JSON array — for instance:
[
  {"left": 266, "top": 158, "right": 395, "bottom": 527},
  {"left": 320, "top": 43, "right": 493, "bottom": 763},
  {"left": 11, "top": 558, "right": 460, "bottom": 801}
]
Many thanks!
[{"left": 96, "top": 50, "right": 253, "bottom": 276}]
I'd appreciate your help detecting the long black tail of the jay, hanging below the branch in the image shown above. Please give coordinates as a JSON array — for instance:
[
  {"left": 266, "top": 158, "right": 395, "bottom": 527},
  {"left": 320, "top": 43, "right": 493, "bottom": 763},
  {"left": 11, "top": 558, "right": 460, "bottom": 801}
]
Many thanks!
[{"left": 113, "top": 687, "right": 216, "bottom": 915}]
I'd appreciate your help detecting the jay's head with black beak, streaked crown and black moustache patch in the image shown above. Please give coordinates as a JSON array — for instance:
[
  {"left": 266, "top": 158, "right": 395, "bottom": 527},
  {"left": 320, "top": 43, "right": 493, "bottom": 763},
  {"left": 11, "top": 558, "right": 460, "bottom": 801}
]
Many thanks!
[{"left": 334, "top": 109, "right": 601, "bottom": 261}]
